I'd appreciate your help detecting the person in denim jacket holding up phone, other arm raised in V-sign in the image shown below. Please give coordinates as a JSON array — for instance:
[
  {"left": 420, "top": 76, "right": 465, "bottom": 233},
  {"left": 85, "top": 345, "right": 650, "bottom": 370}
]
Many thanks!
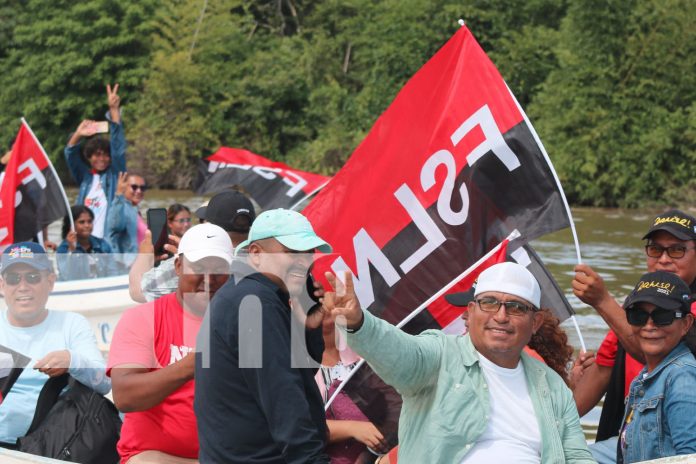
[{"left": 64, "top": 84, "right": 126, "bottom": 238}]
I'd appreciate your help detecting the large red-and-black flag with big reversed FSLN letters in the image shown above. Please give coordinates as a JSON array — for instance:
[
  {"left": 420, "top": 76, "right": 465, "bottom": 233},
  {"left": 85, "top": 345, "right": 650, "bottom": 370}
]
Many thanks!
[{"left": 304, "top": 23, "right": 570, "bottom": 324}]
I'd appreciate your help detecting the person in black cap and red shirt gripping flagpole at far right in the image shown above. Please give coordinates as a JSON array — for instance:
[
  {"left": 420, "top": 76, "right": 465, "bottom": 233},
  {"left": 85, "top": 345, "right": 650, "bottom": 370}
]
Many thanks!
[{"left": 572, "top": 210, "right": 696, "bottom": 464}]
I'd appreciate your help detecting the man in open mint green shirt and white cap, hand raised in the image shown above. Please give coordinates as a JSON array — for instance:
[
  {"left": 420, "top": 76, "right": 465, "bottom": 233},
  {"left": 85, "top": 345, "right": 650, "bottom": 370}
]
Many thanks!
[{"left": 324, "top": 263, "right": 595, "bottom": 464}]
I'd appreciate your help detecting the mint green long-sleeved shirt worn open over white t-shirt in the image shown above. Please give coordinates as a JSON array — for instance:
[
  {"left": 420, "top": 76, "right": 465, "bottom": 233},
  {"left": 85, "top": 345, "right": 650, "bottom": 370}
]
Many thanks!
[{"left": 347, "top": 311, "right": 596, "bottom": 464}]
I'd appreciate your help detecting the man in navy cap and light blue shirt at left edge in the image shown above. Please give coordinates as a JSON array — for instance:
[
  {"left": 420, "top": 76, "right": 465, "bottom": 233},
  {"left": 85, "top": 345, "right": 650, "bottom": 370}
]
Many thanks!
[{"left": 0, "top": 242, "right": 111, "bottom": 447}]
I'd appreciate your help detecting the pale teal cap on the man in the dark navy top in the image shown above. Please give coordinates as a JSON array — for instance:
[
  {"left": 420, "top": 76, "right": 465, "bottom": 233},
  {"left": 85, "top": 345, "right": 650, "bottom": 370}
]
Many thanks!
[{"left": 235, "top": 208, "right": 331, "bottom": 255}]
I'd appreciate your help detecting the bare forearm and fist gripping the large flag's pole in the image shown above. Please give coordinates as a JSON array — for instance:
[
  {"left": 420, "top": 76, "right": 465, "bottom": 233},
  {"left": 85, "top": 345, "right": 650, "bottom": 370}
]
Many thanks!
[{"left": 572, "top": 264, "right": 645, "bottom": 363}]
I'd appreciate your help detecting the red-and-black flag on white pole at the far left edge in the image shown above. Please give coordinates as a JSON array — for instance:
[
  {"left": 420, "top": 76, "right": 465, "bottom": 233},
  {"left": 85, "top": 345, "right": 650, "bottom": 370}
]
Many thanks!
[{"left": 0, "top": 119, "right": 69, "bottom": 247}]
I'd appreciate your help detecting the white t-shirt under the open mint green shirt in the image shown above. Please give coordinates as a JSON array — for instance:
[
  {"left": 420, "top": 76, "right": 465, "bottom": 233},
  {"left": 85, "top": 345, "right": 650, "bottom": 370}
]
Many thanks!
[{"left": 462, "top": 353, "right": 541, "bottom": 464}]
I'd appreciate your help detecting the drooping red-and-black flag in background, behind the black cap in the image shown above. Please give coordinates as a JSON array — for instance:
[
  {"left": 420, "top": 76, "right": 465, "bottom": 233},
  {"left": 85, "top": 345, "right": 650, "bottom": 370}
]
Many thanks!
[{"left": 196, "top": 147, "right": 329, "bottom": 209}]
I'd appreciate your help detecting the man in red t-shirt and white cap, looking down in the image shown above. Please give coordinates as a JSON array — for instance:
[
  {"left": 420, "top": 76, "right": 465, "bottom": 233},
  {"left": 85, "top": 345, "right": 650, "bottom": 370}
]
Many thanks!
[{"left": 107, "top": 224, "right": 232, "bottom": 464}]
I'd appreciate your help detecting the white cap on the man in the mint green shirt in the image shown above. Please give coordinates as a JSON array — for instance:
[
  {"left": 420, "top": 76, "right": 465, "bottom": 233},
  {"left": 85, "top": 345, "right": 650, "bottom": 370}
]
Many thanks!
[{"left": 474, "top": 262, "right": 541, "bottom": 308}]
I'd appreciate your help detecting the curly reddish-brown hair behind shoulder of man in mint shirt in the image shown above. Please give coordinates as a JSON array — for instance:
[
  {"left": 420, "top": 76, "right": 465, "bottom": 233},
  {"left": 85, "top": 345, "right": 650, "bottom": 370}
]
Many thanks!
[{"left": 529, "top": 308, "right": 573, "bottom": 385}]
